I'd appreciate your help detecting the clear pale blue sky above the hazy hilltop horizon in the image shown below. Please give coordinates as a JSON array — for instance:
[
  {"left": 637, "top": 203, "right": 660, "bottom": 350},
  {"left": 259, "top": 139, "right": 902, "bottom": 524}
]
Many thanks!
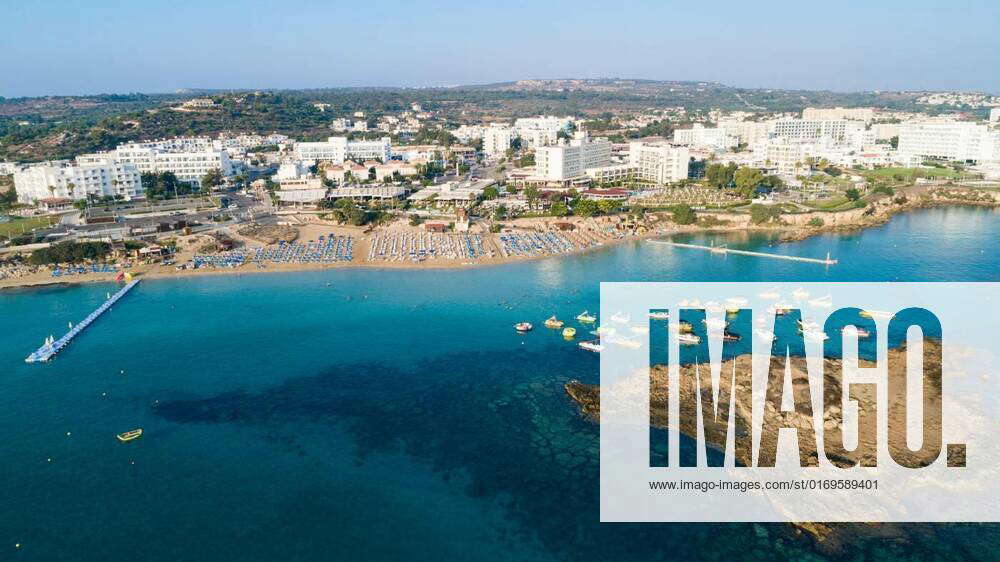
[{"left": 0, "top": 0, "right": 1000, "bottom": 97}]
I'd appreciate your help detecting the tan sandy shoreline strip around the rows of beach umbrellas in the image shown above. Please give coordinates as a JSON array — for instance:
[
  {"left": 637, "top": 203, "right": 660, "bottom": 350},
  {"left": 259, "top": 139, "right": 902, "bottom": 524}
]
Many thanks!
[{"left": 0, "top": 190, "right": 1000, "bottom": 289}]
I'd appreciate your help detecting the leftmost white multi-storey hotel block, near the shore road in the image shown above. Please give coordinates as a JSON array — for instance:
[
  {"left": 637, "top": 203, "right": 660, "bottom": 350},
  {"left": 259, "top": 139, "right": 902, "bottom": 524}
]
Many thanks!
[{"left": 14, "top": 155, "right": 145, "bottom": 203}]
